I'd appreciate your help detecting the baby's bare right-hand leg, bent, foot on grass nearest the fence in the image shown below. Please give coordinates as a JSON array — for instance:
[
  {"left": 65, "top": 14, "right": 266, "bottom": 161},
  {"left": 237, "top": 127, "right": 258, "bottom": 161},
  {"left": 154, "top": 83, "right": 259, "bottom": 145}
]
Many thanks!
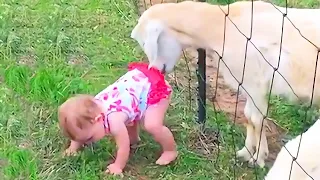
[{"left": 143, "top": 99, "right": 178, "bottom": 165}]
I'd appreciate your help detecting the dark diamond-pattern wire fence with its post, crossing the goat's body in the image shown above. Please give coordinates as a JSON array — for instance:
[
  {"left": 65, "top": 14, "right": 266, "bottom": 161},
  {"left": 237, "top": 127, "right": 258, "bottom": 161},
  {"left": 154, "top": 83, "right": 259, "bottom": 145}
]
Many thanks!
[{"left": 135, "top": 0, "right": 320, "bottom": 179}]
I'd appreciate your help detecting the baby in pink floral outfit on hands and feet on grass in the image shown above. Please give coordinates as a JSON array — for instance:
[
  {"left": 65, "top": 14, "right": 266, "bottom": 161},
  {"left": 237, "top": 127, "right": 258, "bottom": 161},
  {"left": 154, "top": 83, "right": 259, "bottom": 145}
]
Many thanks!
[{"left": 58, "top": 62, "right": 177, "bottom": 174}]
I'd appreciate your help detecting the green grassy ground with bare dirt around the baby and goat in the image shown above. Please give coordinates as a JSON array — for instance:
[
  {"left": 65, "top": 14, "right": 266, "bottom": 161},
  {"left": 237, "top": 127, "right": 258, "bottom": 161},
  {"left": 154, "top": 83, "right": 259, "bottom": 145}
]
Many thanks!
[{"left": 0, "top": 0, "right": 320, "bottom": 180}]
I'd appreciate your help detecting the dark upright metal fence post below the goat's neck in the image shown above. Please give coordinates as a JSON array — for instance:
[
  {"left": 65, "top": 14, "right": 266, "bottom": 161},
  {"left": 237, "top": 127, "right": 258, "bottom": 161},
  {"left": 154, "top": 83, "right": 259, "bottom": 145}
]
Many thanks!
[{"left": 197, "top": 49, "right": 206, "bottom": 124}]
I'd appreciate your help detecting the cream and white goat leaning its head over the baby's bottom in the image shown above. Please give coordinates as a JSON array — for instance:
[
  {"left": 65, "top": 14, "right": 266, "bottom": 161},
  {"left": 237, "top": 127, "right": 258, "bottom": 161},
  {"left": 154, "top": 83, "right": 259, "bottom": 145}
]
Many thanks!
[{"left": 131, "top": 1, "right": 320, "bottom": 167}]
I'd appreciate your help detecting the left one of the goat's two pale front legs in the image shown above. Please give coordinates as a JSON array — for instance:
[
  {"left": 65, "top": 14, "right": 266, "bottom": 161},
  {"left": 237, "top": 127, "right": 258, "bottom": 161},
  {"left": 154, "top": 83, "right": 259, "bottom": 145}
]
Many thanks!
[{"left": 237, "top": 99, "right": 256, "bottom": 161}]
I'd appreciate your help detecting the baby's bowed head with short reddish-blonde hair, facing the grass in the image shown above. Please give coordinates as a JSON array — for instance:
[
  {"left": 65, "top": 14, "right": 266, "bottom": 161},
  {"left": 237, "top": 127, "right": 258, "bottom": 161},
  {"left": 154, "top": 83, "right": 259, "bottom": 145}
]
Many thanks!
[{"left": 58, "top": 94, "right": 105, "bottom": 143}]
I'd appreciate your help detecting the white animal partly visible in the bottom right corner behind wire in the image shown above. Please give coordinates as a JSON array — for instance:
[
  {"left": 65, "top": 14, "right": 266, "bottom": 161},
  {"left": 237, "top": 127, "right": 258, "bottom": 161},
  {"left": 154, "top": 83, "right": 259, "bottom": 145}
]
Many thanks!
[{"left": 265, "top": 119, "right": 320, "bottom": 180}]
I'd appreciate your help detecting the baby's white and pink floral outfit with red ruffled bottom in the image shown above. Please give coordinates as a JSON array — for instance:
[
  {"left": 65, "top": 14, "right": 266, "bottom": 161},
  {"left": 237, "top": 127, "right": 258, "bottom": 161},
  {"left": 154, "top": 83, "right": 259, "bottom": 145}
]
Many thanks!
[{"left": 95, "top": 62, "right": 172, "bottom": 131}]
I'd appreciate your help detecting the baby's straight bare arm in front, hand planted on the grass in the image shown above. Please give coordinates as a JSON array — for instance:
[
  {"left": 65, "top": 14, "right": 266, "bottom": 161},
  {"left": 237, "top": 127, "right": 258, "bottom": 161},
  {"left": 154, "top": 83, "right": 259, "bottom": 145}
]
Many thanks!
[{"left": 107, "top": 112, "right": 130, "bottom": 174}]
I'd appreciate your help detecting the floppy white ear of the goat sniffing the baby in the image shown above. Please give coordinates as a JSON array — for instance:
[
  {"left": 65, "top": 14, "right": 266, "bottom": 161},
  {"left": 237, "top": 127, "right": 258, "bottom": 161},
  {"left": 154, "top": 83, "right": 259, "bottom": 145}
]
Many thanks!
[{"left": 143, "top": 21, "right": 164, "bottom": 63}]
